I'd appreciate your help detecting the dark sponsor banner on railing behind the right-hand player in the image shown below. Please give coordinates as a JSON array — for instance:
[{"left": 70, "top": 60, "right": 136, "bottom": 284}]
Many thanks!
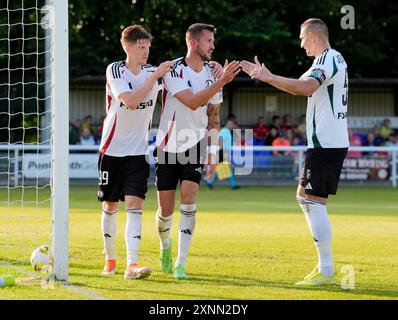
[{"left": 340, "top": 157, "right": 390, "bottom": 181}]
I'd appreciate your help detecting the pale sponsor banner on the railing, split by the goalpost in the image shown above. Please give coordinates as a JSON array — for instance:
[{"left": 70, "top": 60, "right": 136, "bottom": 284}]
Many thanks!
[{"left": 23, "top": 153, "right": 98, "bottom": 179}]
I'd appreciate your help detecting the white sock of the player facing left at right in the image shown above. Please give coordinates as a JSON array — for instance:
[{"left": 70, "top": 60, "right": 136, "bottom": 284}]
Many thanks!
[{"left": 297, "top": 197, "right": 334, "bottom": 277}]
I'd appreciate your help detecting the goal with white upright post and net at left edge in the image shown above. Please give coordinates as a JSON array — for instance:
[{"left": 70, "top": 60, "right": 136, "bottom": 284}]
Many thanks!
[{"left": 0, "top": 0, "right": 69, "bottom": 280}]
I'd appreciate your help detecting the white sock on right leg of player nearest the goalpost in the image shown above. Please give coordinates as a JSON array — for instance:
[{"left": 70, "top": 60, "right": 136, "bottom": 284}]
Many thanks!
[{"left": 125, "top": 209, "right": 142, "bottom": 266}]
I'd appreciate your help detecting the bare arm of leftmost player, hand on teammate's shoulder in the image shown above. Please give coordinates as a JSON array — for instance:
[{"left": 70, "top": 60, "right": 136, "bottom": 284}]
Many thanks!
[{"left": 118, "top": 61, "right": 173, "bottom": 109}]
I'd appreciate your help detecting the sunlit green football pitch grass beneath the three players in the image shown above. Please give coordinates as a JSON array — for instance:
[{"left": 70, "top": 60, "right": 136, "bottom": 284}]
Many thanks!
[{"left": 0, "top": 185, "right": 398, "bottom": 300}]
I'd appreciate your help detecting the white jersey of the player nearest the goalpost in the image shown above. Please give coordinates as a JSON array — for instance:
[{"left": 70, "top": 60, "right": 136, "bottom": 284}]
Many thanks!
[{"left": 100, "top": 61, "right": 161, "bottom": 157}]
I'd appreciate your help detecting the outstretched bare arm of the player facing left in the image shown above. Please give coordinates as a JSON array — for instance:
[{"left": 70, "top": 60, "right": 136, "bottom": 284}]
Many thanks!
[{"left": 240, "top": 56, "right": 319, "bottom": 96}]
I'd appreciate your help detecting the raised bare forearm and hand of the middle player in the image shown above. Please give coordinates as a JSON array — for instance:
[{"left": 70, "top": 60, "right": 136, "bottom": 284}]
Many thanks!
[{"left": 175, "top": 60, "right": 241, "bottom": 110}]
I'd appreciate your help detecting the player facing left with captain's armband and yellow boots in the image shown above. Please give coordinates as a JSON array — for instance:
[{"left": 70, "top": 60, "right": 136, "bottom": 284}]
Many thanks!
[{"left": 241, "top": 18, "right": 349, "bottom": 287}]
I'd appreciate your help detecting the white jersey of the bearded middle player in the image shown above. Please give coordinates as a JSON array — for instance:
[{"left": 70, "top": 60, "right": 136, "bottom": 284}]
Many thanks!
[{"left": 156, "top": 58, "right": 223, "bottom": 153}]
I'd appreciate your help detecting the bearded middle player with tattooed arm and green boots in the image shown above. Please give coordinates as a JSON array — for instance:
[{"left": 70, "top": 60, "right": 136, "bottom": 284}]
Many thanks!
[{"left": 155, "top": 23, "right": 240, "bottom": 279}]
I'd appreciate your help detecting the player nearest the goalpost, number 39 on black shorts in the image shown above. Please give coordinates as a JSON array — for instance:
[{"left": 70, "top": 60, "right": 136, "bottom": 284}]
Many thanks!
[{"left": 98, "top": 25, "right": 173, "bottom": 279}]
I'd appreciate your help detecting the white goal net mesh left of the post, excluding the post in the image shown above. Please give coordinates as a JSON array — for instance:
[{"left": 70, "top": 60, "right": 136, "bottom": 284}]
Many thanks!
[{"left": 0, "top": 0, "right": 52, "bottom": 275}]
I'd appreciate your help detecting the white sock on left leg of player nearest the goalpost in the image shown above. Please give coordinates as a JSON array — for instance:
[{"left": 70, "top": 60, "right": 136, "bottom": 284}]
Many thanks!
[{"left": 101, "top": 209, "right": 118, "bottom": 260}]
